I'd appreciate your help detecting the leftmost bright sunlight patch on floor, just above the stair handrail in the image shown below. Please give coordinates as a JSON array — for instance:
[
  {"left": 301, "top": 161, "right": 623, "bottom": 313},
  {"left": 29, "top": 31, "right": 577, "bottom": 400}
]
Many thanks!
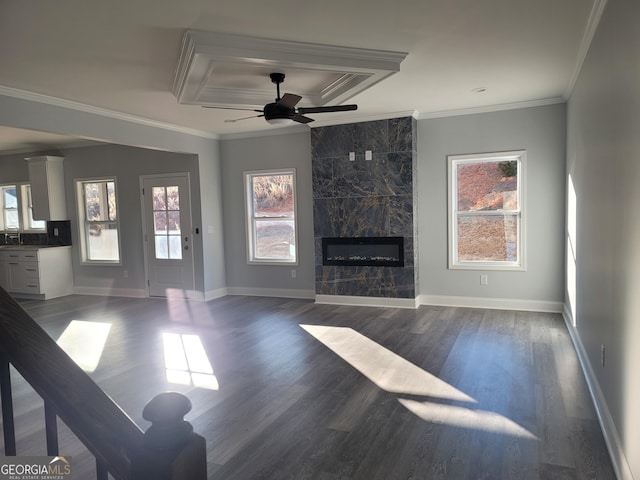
[{"left": 56, "top": 320, "right": 111, "bottom": 373}]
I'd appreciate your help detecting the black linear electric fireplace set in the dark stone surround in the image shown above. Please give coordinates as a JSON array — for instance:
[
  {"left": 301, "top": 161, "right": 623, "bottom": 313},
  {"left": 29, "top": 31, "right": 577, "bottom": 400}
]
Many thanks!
[{"left": 322, "top": 237, "right": 404, "bottom": 267}]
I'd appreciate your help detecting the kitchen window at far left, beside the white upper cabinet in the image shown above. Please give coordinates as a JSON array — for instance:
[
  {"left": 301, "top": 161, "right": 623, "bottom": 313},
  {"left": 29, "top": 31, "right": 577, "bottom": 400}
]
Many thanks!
[{"left": 0, "top": 183, "right": 47, "bottom": 232}]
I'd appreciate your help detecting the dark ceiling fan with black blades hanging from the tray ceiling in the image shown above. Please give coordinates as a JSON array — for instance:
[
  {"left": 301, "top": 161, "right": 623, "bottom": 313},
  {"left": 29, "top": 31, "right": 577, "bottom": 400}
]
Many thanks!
[{"left": 203, "top": 73, "right": 358, "bottom": 125}]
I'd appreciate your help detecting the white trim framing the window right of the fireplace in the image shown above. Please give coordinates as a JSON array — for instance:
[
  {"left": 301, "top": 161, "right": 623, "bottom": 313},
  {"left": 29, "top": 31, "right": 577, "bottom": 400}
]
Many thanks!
[{"left": 447, "top": 150, "right": 527, "bottom": 271}]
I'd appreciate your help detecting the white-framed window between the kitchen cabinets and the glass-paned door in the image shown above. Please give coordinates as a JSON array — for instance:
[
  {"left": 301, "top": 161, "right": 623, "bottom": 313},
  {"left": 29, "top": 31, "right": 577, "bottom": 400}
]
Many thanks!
[{"left": 76, "top": 178, "right": 120, "bottom": 264}]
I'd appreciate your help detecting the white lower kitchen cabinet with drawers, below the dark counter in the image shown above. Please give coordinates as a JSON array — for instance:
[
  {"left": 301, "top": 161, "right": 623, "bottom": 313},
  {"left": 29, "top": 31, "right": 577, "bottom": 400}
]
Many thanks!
[{"left": 0, "top": 246, "right": 73, "bottom": 300}]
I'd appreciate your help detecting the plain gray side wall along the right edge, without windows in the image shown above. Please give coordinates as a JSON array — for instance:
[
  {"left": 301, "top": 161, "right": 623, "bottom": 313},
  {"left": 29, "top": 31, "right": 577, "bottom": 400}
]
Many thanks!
[{"left": 567, "top": 0, "right": 640, "bottom": 478}]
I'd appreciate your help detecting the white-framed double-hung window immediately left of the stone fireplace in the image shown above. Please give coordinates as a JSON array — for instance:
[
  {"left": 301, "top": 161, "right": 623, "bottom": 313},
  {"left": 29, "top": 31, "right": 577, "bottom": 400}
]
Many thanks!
[{"left": 245, "top": 169, "right": 298, "bottom": 265}]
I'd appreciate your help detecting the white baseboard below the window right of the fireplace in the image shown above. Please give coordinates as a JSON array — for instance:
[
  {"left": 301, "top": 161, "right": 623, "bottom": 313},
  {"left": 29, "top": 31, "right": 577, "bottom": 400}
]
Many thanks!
[{"left": 419, "top": 295, "right": 563, "bottom": 313}]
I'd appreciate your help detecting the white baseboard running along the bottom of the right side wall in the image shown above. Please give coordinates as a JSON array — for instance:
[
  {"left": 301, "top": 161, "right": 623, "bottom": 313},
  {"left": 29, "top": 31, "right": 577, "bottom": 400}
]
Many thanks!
[{"left": 562, "top": 305, "right": 633, "bottom": 480}]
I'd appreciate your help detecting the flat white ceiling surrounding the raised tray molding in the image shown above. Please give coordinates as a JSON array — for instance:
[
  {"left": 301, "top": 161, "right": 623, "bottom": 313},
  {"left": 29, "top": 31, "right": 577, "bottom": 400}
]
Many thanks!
[{"left": 0, "top": 0, "right": 606, "bottom": 151}]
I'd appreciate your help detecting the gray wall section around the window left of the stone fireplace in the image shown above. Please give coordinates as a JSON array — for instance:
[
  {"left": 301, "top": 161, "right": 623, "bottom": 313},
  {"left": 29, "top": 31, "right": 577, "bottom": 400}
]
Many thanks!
[{"left": 220, "top": 131, "right": 315, "bottom": 298}]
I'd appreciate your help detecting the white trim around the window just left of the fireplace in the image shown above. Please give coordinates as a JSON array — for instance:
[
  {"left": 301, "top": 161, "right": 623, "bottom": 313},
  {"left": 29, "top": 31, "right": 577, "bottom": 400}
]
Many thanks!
[{"left": 243, "top": 168, "right": 300, "bottom": 266}]
